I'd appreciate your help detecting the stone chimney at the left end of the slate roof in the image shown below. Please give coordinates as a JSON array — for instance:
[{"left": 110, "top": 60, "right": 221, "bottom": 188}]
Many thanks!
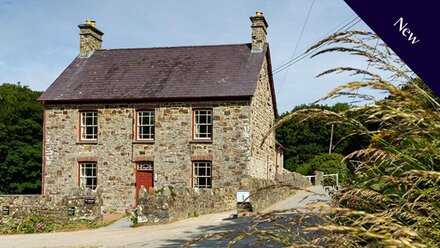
[{"left": 78, "top": 20, "right": 104, "bottom": 58}]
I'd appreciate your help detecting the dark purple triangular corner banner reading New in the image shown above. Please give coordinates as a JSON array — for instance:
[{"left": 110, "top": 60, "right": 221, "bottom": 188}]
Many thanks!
[{"left": 345, "top": 0, "right": 440, "bottom": 96}]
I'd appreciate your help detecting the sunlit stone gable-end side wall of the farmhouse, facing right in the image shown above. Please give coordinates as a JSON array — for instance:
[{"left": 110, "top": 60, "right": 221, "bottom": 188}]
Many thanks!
[{"left": 248, "top": 59, "right": 276, "bottom": 180}]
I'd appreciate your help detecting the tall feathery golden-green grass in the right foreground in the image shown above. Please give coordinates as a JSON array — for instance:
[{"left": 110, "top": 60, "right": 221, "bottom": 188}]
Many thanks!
[{"left": 183, "top": 30, "right": 440, "bottom": 247}]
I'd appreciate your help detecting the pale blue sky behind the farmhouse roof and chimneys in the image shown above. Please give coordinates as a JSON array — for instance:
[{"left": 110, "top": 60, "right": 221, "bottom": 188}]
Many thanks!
[{"left": 0, "top": 0, "right": 374, "bottom": 113}]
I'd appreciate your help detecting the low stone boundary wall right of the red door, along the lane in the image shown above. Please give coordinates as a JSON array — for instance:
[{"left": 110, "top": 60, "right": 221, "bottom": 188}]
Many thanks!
[{"left": 134, "top": 173, "right": 311, "bottom": 224}]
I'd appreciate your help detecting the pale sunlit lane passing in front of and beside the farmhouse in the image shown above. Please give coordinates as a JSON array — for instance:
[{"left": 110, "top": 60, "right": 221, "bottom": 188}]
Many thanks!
[{"left": 0, "top": 187, "right": 329, "bottom": 248}]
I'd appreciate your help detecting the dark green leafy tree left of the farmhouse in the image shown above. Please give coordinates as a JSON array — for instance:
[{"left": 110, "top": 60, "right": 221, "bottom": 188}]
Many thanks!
[{"left": 0, "top": 83, "right": 43, "bottom": 194}]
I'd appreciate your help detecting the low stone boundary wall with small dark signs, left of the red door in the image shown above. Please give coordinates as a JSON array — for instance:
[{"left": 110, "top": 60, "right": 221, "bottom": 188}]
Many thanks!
[{"left": 0, "top": 189, "right": 102, "bottom": 227}]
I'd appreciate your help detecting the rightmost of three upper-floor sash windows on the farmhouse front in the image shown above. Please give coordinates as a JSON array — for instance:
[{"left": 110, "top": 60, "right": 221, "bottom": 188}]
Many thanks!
[{"left": 193, "top": 109, "right": 212, "bottom": 140}]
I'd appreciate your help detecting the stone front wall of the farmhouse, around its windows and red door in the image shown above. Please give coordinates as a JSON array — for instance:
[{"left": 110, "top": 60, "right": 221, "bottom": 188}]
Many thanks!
[{"left": 44, "top": 101, "right": 253, "bottom": 212}]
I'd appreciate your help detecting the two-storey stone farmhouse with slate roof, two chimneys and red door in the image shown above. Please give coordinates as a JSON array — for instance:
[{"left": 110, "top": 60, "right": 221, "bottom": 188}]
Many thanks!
[{"left": 39, "top": 12, "right": 283, "bottom": 211}]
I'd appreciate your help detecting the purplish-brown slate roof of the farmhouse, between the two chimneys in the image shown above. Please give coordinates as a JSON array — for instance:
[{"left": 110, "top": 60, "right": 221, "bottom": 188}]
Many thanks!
[{"left": 39, "top": 44, "right": 273, "bottom": 102}]
